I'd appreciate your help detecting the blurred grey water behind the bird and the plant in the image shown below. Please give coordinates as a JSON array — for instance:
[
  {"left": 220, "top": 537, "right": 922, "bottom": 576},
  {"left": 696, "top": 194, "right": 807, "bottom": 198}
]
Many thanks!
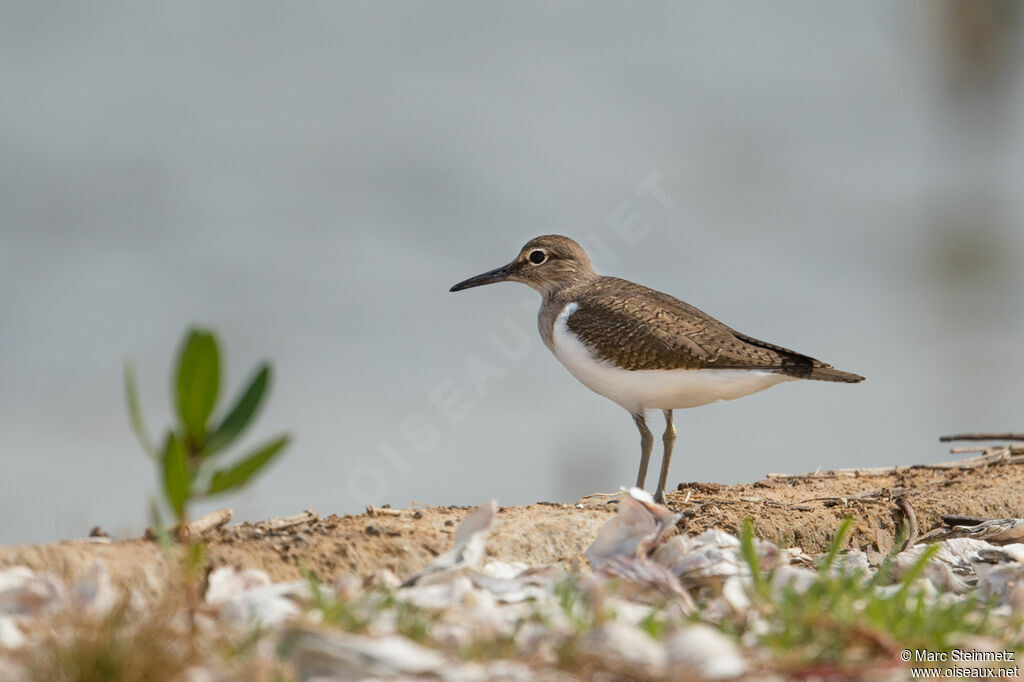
[{"left": 0, "top": 0, "right": 1024, "bottom": 543}]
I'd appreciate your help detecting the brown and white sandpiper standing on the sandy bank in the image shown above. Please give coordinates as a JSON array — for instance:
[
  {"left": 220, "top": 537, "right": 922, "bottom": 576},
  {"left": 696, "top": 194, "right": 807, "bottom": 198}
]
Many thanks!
[{"left": 451, "top": 235, "right": 864, "bottom": 502}]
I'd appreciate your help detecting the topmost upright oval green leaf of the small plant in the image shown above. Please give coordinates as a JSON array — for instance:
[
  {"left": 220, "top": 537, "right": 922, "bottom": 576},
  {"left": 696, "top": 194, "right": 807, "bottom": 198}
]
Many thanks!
[{"left": 176, "top": 329, "right": 220, "bottom": 443}]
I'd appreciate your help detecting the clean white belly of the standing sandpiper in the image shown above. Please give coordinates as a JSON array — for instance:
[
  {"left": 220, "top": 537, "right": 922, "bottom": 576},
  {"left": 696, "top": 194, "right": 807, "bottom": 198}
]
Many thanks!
[{"left": 552, "top": 303, "right": 795, "bottom": 414}]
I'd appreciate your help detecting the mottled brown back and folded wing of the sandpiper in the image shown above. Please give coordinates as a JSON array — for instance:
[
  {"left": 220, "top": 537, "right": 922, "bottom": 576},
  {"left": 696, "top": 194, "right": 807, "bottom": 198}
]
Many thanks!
[{"left": 565, "top": 276, "right": 864, "bottom": 383}]
